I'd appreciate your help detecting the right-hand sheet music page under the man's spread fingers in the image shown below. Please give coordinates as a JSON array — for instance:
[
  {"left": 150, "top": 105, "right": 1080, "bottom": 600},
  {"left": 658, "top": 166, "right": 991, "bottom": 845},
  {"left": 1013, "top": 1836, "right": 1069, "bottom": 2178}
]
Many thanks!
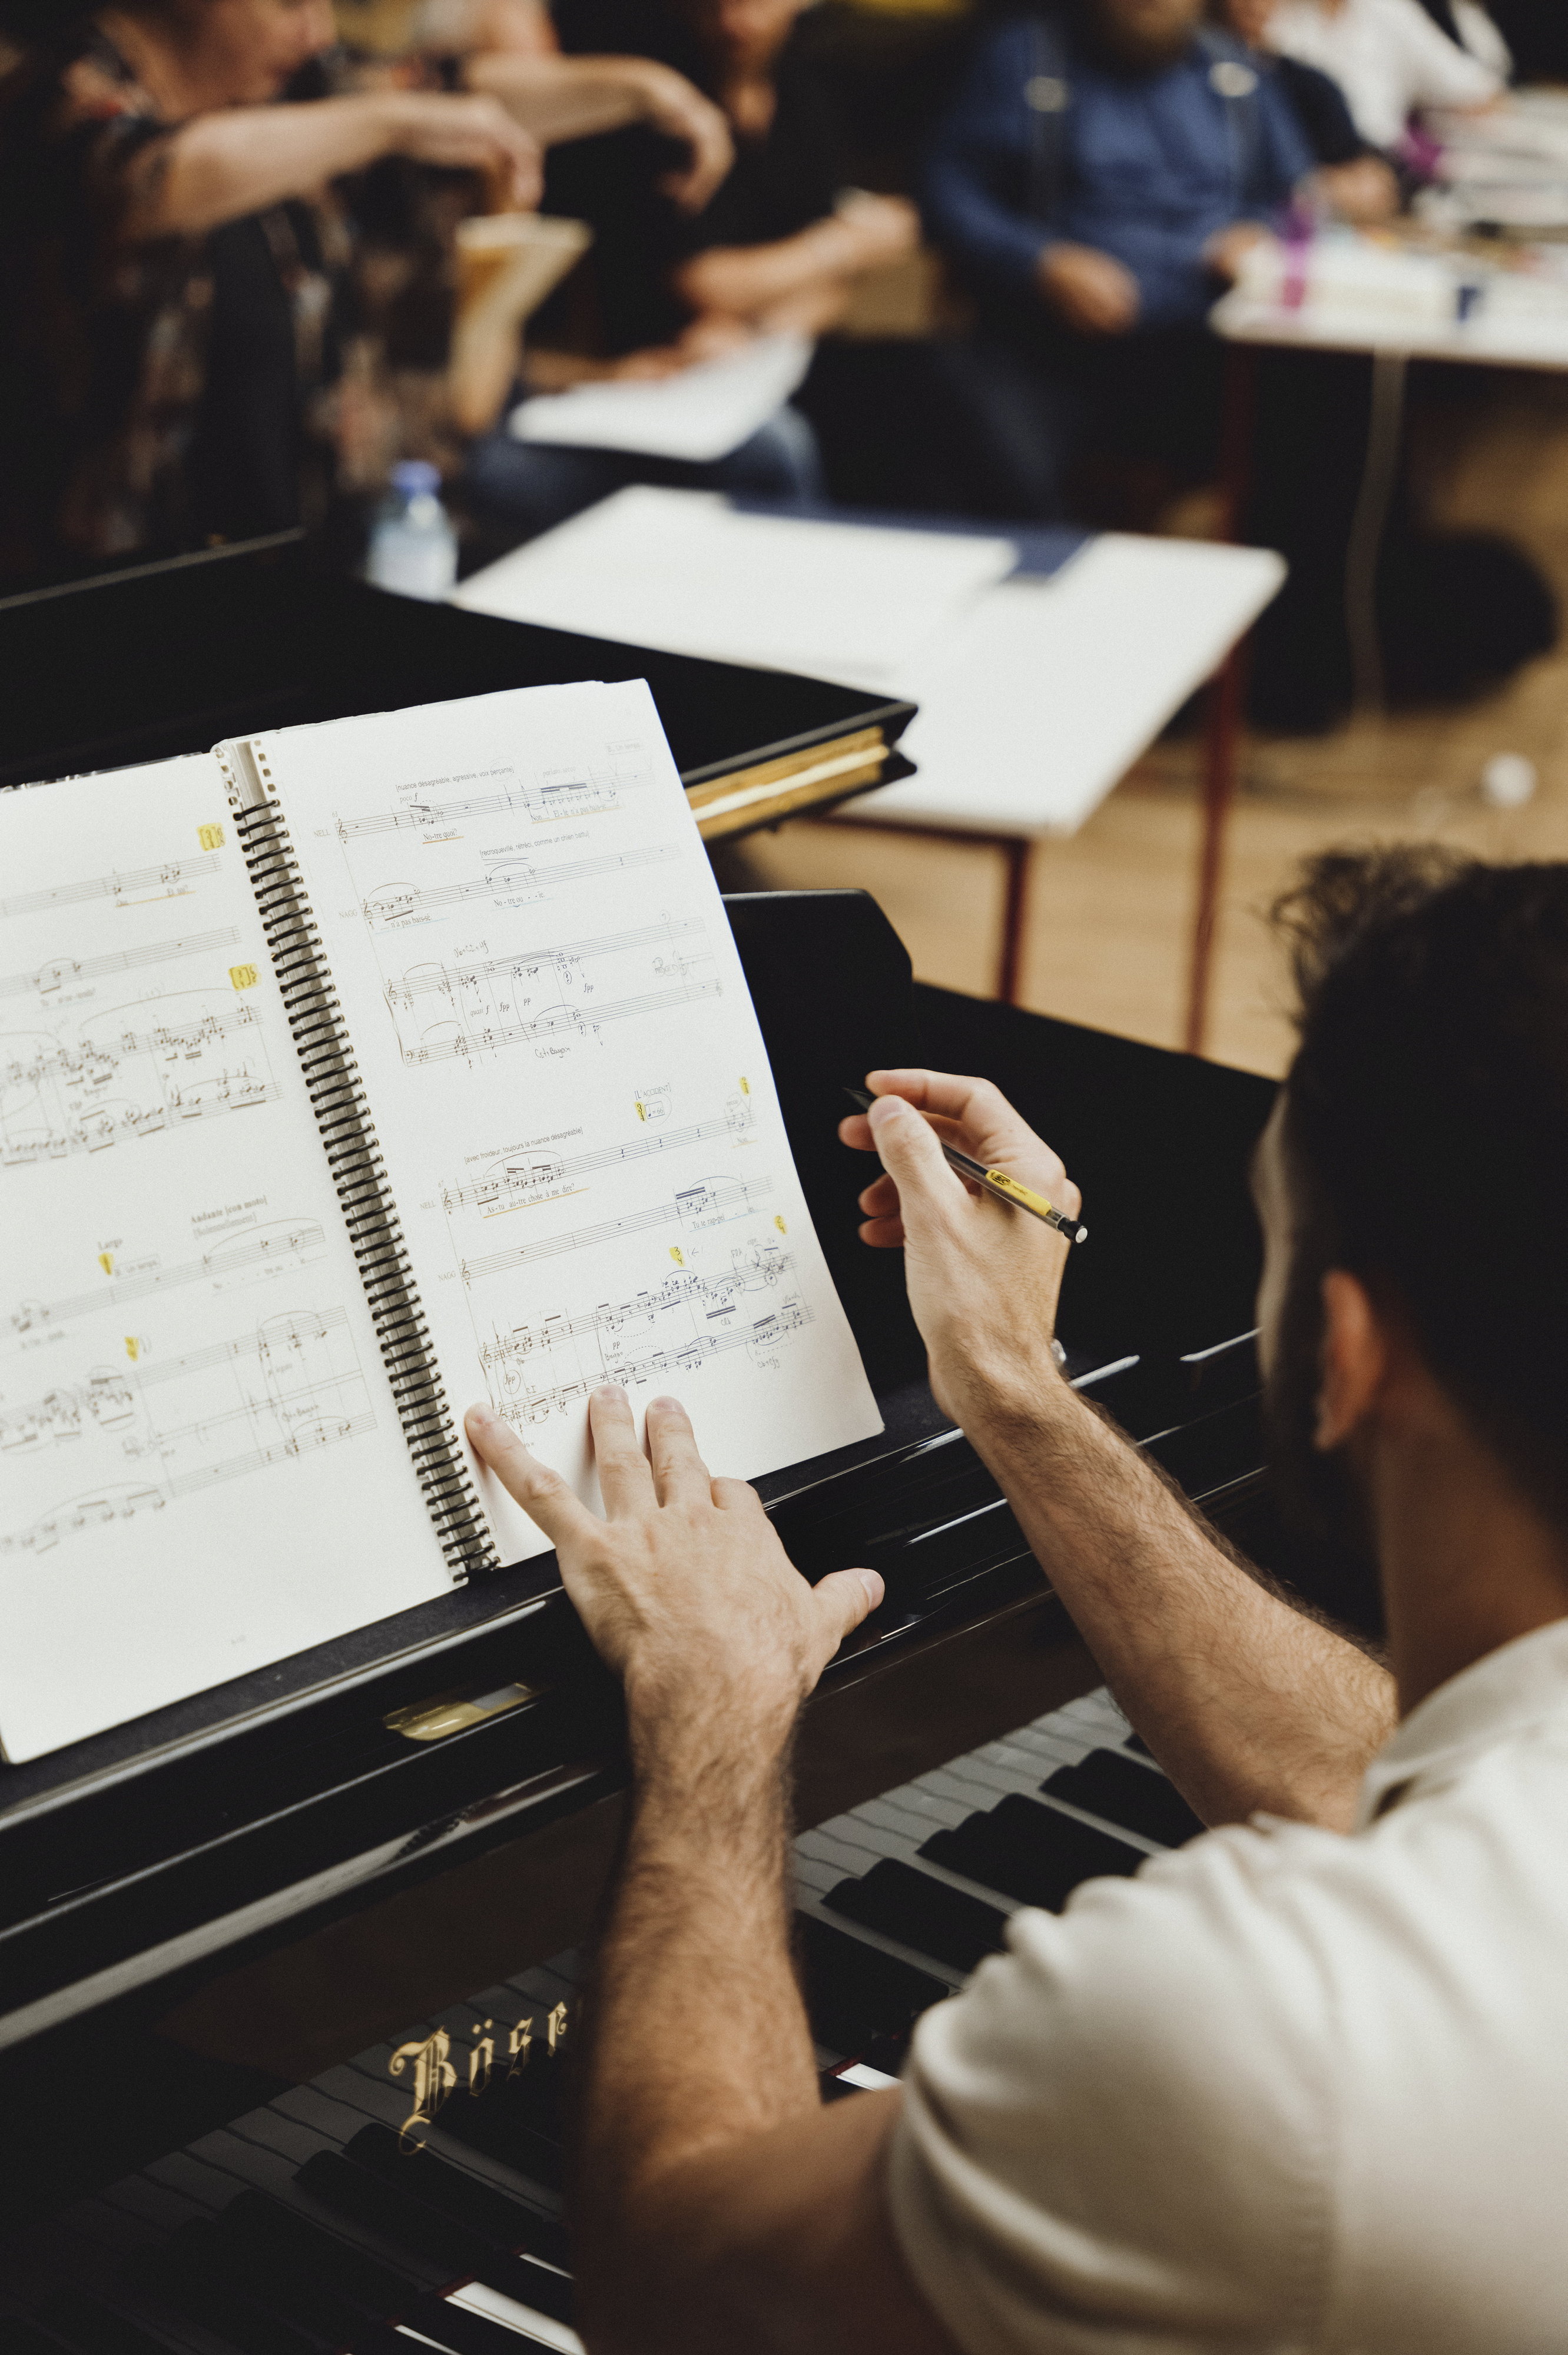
[{"left": 257, "top": 681, "right": 880, "bottom": 1561}]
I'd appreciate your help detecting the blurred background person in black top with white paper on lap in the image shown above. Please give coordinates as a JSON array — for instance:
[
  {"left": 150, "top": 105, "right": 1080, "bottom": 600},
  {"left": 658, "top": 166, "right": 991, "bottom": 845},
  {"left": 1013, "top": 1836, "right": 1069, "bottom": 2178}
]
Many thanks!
[{"left": 464, "top": 0, "right": 918, "bottom": 537}]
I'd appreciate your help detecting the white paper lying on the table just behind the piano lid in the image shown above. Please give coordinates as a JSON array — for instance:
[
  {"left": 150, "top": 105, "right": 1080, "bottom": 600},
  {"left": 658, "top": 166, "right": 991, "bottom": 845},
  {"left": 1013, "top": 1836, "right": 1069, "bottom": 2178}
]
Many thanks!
[{"left": 455, "top": 485, "right": 1017, "bottom": 695}]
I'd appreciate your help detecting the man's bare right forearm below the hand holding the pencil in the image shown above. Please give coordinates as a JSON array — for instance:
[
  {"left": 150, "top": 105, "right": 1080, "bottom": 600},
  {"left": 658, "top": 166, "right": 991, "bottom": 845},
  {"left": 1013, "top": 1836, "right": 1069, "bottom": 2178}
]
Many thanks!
[{"left": 960, "top": 1368, "right": 1396, "bottom": 1827}]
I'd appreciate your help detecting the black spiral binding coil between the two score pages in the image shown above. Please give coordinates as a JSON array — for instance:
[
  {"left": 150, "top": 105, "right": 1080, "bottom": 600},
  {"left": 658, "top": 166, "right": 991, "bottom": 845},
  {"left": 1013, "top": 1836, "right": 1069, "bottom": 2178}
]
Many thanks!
[{"left": 219, "top": 742, "right": 499, "bottom": 1583}]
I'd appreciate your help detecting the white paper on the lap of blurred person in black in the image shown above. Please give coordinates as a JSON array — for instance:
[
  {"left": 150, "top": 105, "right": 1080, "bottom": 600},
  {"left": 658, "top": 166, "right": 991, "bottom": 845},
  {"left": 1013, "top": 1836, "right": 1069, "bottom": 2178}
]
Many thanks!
[{"left": 506, "top": 334, "right": 812, "bottom": 464}]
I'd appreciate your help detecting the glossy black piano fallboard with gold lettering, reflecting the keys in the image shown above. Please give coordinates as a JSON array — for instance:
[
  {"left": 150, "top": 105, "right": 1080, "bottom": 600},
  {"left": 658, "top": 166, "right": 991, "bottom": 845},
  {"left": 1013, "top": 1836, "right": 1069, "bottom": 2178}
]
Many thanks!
[{"left": 0, "top": 1691, "right": 1196, "bottom": 2355}]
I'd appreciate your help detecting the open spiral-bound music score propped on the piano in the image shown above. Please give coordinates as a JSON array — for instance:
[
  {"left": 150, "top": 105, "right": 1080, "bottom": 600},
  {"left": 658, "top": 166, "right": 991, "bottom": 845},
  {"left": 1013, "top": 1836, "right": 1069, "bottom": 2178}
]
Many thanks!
[{"left": 0, "top": 683, "right": 880, "bottom": 1759}]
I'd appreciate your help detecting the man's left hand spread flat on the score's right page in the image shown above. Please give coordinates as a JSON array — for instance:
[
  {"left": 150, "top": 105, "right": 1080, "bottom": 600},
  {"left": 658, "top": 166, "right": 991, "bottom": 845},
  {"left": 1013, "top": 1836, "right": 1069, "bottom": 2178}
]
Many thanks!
[{"left": 466, "top": 1385, "right": 883, "bottom": 1743}]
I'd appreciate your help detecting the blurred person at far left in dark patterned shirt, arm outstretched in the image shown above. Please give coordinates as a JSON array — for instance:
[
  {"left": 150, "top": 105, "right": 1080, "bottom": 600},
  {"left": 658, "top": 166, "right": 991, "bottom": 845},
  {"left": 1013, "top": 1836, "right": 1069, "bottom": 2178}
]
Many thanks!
[{"left": 0, "top": 0, "right": 539, "bottom": 584}]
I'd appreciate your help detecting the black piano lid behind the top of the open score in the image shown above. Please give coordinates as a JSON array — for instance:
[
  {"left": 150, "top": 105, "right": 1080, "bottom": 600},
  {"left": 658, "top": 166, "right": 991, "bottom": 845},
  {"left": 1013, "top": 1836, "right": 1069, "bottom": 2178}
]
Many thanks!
[{"left": 0, "top": 535, "right": 913, "bottom": 787}]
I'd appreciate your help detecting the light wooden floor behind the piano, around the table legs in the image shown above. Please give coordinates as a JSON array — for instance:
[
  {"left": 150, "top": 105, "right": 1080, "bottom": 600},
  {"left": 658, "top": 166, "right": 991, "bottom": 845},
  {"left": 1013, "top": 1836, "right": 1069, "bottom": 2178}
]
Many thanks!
[{"left": 747, "top": 379, "right": 1568, "bottom": 1074}]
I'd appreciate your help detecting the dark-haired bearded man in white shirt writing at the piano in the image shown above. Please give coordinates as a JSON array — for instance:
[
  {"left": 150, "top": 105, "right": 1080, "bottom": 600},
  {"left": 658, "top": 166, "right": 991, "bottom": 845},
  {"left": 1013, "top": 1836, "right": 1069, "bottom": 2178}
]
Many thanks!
[{"left": 473, "top": 850, "right": 1568, "bottom": 2355}]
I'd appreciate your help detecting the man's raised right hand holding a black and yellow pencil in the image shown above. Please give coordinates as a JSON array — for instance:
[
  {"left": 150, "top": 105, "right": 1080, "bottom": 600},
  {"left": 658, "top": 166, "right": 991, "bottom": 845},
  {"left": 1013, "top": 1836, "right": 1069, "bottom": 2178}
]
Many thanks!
[{"left": 838, "top": 1072, "right": 1078, "bottom": 1422}]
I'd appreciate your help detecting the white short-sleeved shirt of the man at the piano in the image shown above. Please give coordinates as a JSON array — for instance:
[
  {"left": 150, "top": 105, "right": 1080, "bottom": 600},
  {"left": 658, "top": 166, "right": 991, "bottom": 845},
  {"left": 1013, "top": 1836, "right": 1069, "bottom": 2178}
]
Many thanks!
[{"left": 890, "top": 1620, "right": 1568, "bottom": 2355}]
